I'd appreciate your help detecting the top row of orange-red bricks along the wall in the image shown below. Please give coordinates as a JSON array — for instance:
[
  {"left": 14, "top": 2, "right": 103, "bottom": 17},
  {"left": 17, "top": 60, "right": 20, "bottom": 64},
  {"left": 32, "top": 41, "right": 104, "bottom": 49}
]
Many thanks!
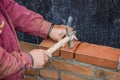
[{"left": 40, "top": 39, "right": 120, "bottom": 68}]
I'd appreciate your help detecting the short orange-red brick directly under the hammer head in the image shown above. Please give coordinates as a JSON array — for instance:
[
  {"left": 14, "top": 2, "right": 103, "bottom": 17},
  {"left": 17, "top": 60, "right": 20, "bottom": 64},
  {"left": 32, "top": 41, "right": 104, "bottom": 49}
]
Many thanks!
[{"left": 60, "top": 41, "right": 80, "bottom": 60}]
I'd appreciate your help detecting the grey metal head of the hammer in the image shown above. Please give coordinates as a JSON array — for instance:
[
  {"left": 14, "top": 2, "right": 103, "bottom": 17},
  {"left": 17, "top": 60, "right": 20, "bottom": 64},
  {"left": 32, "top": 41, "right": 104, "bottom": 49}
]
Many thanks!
[{"left": 66, "top": 27, "right": 77, "bottom": 48}]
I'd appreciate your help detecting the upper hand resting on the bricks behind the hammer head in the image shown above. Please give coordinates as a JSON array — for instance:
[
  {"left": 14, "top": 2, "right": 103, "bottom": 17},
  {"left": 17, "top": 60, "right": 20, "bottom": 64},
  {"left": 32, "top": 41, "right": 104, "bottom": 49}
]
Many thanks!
[{"left": 49, "top": 25, "right": 73, "bottom": 41}]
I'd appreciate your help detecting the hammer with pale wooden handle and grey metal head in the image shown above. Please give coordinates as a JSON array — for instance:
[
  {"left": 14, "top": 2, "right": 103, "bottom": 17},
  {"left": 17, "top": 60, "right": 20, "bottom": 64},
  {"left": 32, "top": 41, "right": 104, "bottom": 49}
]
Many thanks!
[{"left": 47, "top": 26, "right": 77, "bottom": 57}]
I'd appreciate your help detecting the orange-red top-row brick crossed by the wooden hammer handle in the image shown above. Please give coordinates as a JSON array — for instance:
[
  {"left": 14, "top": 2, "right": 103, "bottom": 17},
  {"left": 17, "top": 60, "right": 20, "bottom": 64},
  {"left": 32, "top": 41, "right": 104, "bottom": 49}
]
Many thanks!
[{"left": 39, "top": 39, "right": 60, "bottom": 56}]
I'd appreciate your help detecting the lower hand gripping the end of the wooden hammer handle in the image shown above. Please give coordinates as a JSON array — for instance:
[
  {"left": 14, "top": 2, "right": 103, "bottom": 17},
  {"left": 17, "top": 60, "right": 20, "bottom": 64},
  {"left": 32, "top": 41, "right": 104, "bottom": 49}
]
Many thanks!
[{"left": 29, "top": 49, "right": 49, "bottom": 68}]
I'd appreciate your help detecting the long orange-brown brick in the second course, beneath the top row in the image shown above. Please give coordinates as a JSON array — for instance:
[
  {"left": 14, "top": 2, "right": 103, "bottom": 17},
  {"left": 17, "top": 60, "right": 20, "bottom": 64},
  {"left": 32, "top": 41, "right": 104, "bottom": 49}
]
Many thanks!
[{"left": 53, "top": 60, "right": 93, "bottom": 76}]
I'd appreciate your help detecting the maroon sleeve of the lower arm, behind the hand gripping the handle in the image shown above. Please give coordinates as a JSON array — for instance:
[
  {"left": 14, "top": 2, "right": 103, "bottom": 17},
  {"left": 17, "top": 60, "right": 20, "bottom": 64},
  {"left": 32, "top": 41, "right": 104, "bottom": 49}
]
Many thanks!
[{"left": 0, "top": 47, "right": 32, "bottom": 79}]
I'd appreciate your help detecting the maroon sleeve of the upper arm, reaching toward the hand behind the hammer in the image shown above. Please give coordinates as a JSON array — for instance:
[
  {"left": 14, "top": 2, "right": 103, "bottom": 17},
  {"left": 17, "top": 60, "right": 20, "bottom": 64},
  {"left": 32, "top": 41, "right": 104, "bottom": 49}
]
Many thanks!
[{"left": 2, "top": 0, "right": 51, "bottom": 38}]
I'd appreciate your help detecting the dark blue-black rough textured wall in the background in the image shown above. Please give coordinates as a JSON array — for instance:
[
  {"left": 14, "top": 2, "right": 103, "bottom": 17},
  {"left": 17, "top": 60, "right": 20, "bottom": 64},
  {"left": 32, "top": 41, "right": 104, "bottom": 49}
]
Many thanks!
[{"left": 16, "top": 0, "right": 120, "bottom": 47}]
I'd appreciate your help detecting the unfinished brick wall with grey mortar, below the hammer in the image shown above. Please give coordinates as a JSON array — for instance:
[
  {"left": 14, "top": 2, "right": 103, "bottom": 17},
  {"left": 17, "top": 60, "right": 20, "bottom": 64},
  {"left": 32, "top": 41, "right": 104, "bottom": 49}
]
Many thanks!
[{"left": 20, "top": 39, "right": 120, "bottom": 80}]
